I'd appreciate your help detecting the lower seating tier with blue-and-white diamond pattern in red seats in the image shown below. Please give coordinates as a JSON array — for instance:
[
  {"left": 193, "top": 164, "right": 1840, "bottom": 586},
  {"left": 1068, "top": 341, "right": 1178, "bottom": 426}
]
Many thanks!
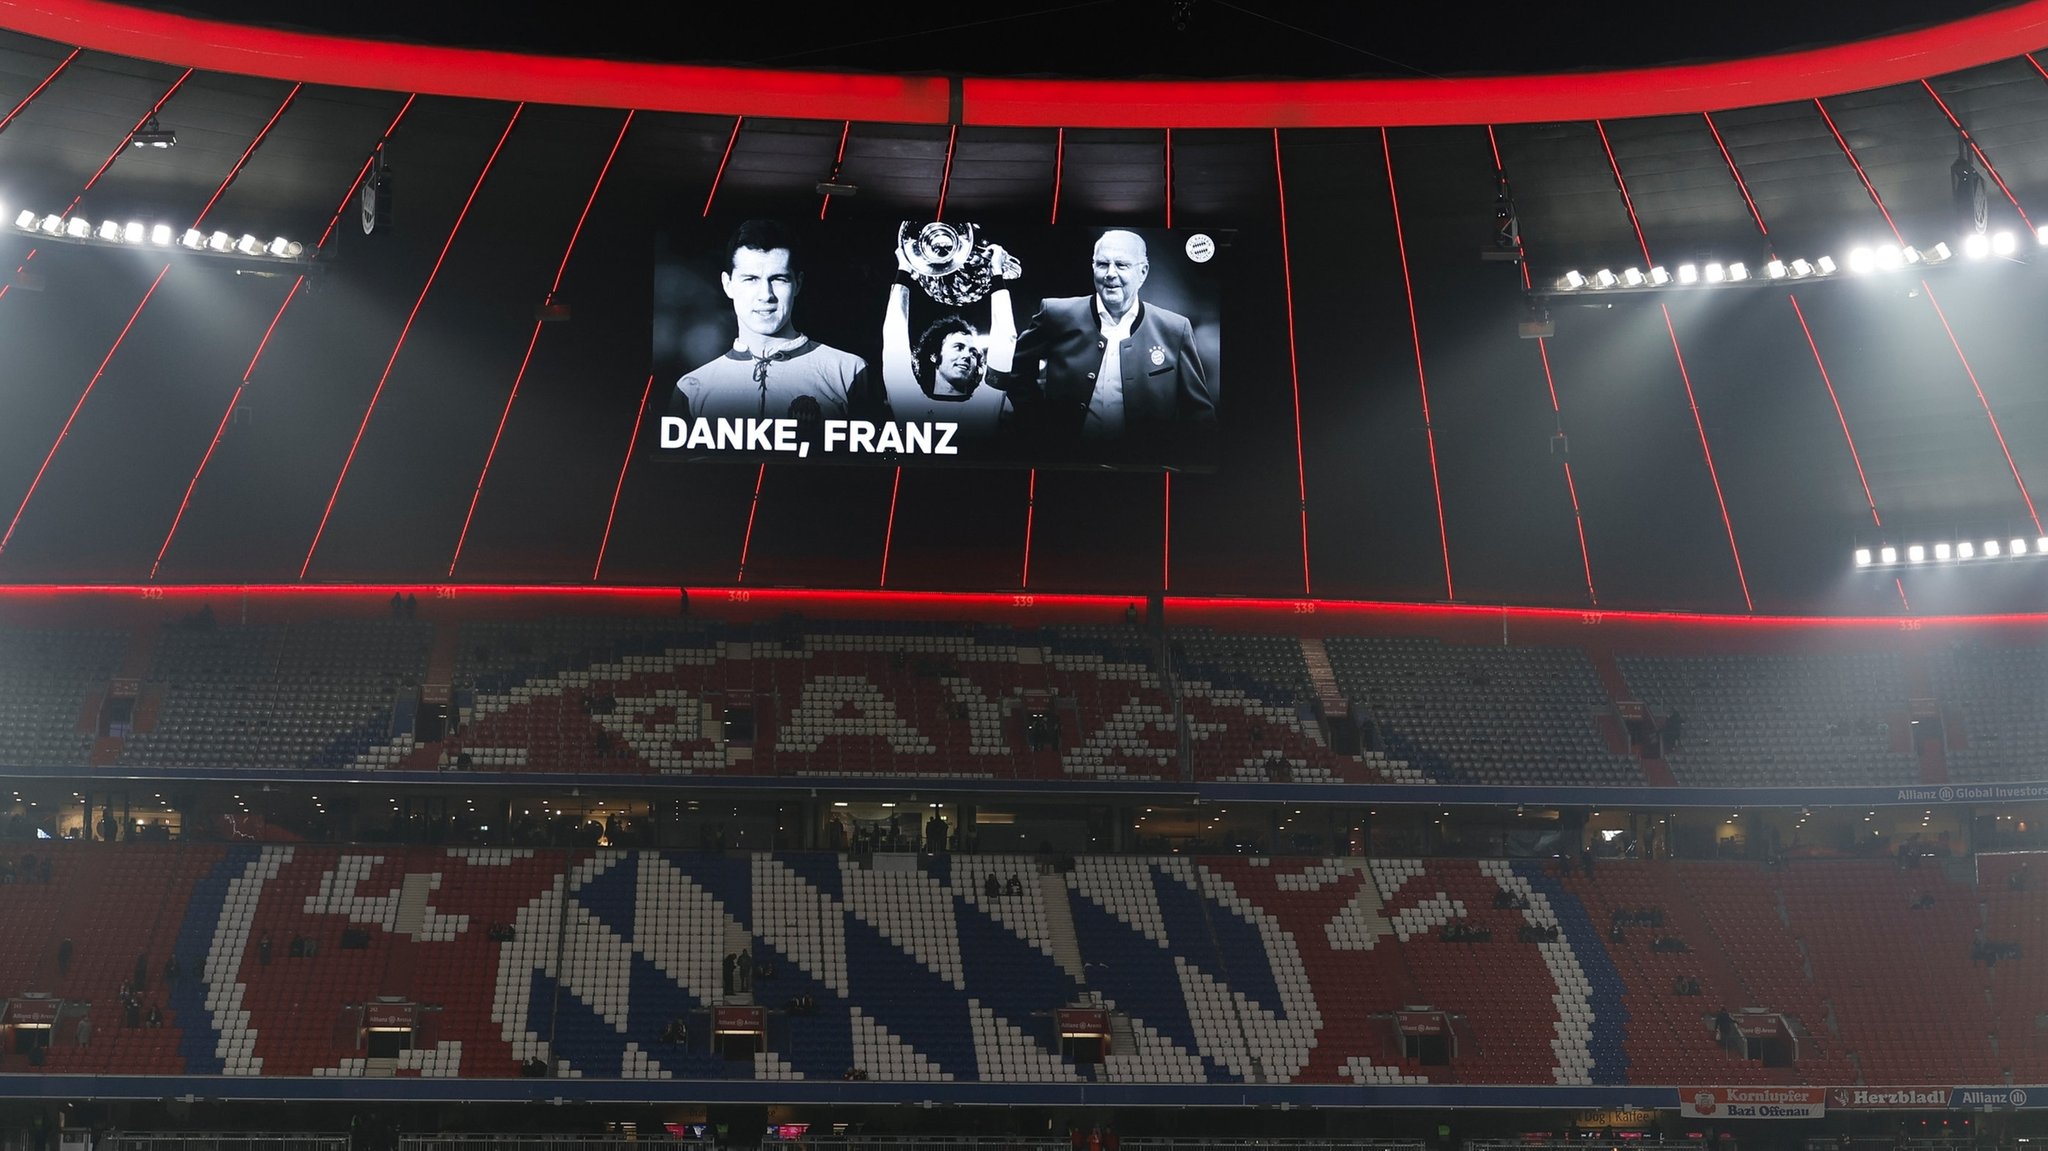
[{"left": 0, "top": 844, "right": 2048, "bottom": 1085}]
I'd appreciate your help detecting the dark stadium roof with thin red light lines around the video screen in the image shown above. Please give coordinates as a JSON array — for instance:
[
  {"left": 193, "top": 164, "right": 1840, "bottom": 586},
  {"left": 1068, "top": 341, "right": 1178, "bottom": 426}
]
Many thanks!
[{"left": 0, "top": 0, "right": 2048, "bottom": 612}]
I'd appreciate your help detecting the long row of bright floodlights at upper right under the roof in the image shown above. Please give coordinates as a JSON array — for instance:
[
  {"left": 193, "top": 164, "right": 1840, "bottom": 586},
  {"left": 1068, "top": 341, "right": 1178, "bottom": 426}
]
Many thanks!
[{"left": 1530, "top": 223, "right": 2048, "bottom": 297}]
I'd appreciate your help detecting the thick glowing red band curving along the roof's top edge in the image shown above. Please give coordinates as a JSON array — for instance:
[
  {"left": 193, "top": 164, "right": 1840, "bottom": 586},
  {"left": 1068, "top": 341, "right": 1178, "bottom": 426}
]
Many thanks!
[{"left": 16, "top": 0, "right": 2048, "bottom": 129}]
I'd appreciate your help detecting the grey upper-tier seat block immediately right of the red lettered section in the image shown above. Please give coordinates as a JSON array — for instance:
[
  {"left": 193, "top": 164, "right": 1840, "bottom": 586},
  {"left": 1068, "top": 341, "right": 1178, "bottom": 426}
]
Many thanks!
[{"left": 1325, "top": 635, "right": 1642, "bottom": 784}]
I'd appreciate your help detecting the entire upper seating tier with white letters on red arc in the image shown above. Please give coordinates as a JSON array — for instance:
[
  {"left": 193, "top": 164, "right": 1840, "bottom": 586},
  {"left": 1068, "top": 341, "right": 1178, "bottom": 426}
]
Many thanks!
[{"left": 0, "top": 614, "right": 2048, "bottom": 786}]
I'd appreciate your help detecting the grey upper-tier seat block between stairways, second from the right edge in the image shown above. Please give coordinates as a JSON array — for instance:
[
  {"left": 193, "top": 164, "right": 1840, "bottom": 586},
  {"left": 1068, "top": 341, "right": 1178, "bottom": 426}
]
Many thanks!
[{"left": 1618, "top": 651, "right": 1919, "bottom": 786}]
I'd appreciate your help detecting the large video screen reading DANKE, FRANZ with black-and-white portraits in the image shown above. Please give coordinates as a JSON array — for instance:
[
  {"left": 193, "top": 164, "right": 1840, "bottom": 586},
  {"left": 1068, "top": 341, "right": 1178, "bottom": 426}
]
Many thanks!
[{"left": 643, "top": 215, "right": 1229, "bottom": 471}]
